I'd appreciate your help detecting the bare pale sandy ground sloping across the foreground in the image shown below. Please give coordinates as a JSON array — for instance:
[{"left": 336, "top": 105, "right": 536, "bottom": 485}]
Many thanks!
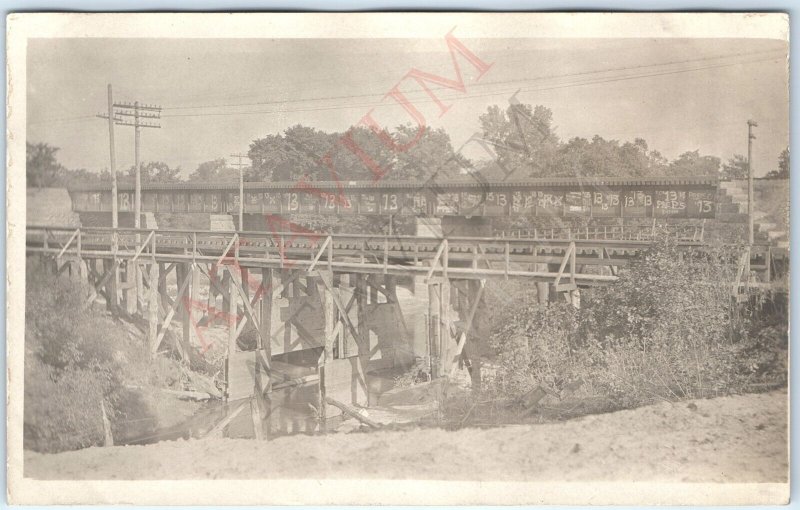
[{"left": 25, "top": 391, "right": 788, "bottom": 482}]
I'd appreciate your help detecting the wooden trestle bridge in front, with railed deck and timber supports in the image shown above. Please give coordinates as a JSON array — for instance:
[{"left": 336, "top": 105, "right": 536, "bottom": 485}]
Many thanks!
[{"left": 27, "top": 227, "right": 776, "bottom": 438}]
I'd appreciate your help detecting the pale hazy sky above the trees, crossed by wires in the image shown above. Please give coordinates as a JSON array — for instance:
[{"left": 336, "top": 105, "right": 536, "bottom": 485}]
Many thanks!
[{"left": 26, "top": 38, "right": 789, "bottom": 176}]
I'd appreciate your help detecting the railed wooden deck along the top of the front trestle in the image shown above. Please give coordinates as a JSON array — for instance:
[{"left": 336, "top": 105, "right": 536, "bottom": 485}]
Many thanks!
[{"left": 27, "top": 226, "right": 776, "bottom": 286}]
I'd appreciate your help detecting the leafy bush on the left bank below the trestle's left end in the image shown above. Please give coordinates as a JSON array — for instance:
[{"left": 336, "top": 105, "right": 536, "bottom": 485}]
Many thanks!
[{"left": 24, "top": 259, "right": 159, "bottom": 452}]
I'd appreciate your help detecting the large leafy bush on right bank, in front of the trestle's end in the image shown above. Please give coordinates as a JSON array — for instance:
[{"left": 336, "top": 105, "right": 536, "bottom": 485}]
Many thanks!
[{"left": 487, "top": 242, "right": 787, "bottom": 414}]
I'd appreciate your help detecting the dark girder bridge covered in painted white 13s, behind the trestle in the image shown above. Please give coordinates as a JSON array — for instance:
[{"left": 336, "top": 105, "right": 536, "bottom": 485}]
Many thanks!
[{"left": 70, "top": 176, "right": 718, "bottom": 218}]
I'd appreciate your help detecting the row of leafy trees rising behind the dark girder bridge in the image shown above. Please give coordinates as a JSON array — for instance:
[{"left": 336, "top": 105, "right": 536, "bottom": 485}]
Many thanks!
[{"left": 26, "top": 104, "right": 789, "bottom": 187}]
